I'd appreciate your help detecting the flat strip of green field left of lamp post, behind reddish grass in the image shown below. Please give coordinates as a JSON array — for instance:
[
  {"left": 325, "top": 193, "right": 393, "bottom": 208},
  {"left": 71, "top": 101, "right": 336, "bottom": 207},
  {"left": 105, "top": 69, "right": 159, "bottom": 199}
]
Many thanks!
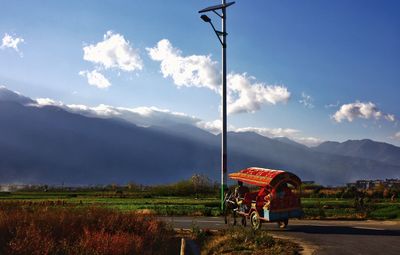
[{"left": 0, "top": 192, "right": 220, "bottom": 216}]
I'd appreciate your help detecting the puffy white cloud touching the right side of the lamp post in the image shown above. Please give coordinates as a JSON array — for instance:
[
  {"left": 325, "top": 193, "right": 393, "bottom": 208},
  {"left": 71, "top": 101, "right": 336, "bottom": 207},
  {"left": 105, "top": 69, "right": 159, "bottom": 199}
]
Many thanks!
[{"left": 227, "top": 73, "right": 290, "bottom": 113}]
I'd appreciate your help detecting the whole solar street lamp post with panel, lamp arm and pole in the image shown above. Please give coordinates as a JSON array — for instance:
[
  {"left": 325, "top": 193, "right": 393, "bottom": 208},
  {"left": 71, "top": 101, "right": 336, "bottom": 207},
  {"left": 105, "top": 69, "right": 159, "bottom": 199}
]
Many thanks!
[{"left": 199, "top": 0, "right": 235, "bottom": 210}]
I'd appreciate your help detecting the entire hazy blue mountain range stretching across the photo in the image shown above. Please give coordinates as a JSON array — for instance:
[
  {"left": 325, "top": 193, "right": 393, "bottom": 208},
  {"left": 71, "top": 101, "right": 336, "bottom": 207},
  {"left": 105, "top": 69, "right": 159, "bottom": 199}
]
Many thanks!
[{"left": 0, "top": 87, "right": 400, "bottom": 185}]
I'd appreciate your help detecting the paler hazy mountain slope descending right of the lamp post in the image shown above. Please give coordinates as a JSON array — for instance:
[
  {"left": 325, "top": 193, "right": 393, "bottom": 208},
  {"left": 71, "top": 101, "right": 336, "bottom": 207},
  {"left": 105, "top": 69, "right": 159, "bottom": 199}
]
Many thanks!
[{"left": 228, "top": 133, "right": 400, "bottom": 184}]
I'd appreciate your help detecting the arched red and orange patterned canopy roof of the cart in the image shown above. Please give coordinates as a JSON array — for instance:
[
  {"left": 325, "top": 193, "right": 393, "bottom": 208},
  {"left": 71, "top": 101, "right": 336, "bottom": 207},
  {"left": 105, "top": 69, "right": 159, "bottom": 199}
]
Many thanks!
[{"left": 229, "top": 167, "right": 301, "bottom": 187}]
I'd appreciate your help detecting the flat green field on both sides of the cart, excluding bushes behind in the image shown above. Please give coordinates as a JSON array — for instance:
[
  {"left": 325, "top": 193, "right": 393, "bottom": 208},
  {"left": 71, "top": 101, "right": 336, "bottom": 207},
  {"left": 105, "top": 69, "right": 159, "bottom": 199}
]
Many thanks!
[{"left": 0, "top": 191, "right": 400, "bottom": 219}]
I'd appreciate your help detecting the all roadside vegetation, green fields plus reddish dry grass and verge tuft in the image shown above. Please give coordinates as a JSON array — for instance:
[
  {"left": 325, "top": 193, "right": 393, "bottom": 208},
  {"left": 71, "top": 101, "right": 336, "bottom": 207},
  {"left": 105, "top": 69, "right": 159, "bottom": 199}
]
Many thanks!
[{"left": 0, "top": 175, "right": 400, "bottom": 254}]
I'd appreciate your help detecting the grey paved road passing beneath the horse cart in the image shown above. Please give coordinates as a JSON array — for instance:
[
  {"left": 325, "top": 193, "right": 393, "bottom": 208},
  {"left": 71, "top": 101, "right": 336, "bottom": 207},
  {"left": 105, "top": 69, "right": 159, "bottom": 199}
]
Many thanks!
[{"left": 161, "top": 217, "right": 400, "bottom": 255}]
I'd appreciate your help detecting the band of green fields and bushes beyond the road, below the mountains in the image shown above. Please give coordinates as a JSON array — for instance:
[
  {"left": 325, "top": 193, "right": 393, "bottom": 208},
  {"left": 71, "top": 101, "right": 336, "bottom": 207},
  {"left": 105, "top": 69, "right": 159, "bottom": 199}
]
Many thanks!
[{"left": 0, "top": 175, "right": 400, "bottom": 220}]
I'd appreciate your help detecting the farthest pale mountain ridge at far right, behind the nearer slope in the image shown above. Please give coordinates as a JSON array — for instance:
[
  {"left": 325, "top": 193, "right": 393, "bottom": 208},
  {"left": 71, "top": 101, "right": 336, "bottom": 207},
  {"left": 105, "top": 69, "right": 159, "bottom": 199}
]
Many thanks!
[{"left": 314, "top": 139, "right": 400, "bottom": 166}]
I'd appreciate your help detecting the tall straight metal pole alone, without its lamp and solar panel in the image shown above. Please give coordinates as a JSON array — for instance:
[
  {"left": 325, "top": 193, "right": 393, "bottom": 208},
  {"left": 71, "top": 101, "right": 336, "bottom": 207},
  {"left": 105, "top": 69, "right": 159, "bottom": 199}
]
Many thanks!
[{"left": 221, "top": 0, "right": 228, "bottom": 210}]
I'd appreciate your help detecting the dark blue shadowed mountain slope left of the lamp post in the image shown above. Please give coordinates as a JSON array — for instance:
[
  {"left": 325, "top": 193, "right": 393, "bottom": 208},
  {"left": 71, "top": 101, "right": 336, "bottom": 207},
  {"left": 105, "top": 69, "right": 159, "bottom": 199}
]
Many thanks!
[{"left": 0, "top": 102, "right": 217, "bottom": 183}]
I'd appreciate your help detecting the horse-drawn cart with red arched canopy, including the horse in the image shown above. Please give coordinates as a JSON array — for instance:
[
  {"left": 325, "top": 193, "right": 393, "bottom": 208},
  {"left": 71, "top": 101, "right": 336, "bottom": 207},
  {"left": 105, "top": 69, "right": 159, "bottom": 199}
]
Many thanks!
[{"left": 225, "top": 167, "right": 303, "bottom": 230}]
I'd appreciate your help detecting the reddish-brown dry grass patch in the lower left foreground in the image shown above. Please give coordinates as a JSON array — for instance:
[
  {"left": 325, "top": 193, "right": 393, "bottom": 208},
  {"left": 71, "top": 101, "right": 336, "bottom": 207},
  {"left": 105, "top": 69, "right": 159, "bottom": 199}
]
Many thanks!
[{"left": 0, "top": 202, "right": 176, "bottom": 255}]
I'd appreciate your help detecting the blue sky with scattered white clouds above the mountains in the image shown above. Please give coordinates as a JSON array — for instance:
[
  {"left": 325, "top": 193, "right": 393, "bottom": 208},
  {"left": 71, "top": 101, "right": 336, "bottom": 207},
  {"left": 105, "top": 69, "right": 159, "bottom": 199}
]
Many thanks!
[{"left": 0, "top": 0, "right": 400, "bottom": 146}]
